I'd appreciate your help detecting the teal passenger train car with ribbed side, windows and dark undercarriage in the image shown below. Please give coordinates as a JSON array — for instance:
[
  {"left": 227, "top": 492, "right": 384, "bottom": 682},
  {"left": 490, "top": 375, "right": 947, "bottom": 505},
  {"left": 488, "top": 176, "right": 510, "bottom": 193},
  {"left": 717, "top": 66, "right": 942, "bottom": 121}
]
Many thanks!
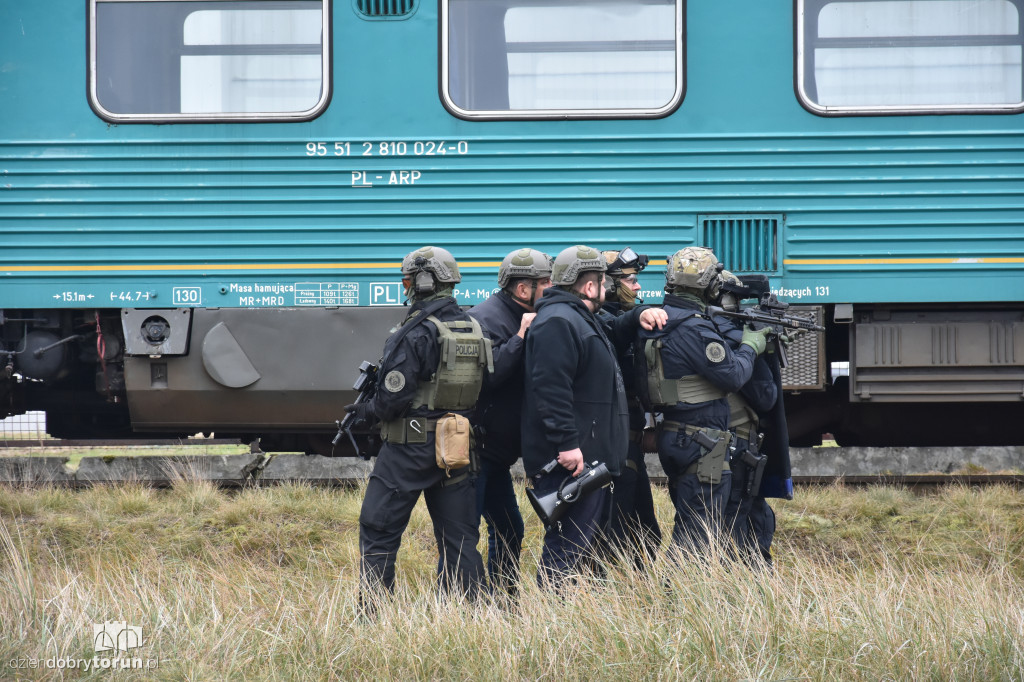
[{"left": 0, "top": 0, "right": 1024, "bottom": 452}]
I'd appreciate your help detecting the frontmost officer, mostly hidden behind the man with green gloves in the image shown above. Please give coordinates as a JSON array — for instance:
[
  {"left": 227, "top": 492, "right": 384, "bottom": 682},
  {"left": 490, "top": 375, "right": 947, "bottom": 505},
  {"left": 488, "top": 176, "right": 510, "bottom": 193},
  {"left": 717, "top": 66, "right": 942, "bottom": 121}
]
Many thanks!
[{"left": 714, "top": 271, "right": 784, "bottom": 563}]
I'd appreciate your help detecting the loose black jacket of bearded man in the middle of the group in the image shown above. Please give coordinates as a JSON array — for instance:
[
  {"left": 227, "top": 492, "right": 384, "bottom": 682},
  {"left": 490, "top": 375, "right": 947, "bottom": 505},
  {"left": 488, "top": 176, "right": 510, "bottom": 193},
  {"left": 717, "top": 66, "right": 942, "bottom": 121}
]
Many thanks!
[{"left": 522, "top": 287, "right": 641, "bottom": 476}]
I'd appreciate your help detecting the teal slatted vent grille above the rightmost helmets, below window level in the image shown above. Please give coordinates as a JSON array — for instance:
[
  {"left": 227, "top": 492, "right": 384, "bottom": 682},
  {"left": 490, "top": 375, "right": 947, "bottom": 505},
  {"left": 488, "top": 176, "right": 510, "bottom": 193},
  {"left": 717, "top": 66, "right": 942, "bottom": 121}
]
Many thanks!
[{"left": 697, "top": 214, "right": 782, "bottom": 272}]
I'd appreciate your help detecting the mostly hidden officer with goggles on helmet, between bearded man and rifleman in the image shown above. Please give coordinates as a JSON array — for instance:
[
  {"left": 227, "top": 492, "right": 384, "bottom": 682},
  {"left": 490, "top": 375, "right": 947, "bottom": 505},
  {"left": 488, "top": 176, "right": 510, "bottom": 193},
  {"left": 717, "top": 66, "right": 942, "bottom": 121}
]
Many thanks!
[{"left": 597, "top": 247, "right": 662, "bottom": 568}]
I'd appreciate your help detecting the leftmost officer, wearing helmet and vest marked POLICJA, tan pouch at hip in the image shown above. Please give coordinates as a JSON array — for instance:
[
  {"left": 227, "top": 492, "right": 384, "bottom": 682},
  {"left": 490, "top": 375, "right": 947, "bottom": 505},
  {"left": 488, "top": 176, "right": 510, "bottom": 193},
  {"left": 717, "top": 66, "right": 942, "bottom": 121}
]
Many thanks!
[{"left": 345, "top": 247, "right": 493, "bottom": 610}]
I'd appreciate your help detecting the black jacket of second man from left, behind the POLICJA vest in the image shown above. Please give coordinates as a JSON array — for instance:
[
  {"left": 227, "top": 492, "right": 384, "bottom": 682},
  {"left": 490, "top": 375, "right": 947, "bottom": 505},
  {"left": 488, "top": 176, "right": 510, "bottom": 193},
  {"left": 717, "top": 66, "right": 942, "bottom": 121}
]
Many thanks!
[{"left": 469, "top": 291, "right": 527, "bottom": 466}]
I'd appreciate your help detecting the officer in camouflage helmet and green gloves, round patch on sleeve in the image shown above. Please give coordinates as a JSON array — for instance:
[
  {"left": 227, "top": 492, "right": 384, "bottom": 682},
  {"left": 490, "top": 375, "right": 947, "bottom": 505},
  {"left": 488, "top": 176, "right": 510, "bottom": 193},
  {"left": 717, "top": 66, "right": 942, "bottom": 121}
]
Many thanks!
[{"left": 639, "top": 247, "right": 767, "bottom": 549}]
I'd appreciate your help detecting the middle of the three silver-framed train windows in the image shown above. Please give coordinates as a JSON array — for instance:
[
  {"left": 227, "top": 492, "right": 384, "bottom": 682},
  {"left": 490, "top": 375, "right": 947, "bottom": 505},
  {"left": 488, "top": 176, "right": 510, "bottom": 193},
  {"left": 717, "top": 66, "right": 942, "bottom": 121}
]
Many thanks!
[{"left": 441, "top": 0, "right": 683, "bottom": 119}]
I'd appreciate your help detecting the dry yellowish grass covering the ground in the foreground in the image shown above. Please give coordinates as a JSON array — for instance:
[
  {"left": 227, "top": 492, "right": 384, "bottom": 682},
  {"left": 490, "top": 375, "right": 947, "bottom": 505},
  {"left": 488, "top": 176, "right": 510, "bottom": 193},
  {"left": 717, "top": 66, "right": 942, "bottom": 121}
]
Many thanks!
[{"left": 0, "top": 480, "right": 1024, "bottom": 680}]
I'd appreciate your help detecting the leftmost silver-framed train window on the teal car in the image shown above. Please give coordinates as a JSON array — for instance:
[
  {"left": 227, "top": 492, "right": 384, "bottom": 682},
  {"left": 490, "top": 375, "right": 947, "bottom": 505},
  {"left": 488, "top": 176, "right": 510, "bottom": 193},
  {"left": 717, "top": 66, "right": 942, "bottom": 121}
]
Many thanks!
[{"left": 89, "top": 0, "right": 330, "bottom": 122}]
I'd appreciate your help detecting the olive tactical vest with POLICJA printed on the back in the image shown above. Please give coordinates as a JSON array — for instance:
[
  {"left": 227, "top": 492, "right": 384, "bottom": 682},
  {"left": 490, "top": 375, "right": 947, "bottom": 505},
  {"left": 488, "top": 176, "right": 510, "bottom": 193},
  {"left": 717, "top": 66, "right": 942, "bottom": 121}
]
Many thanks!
[{"left": 413, "top": 315, "right": 495, "bottom": 410}]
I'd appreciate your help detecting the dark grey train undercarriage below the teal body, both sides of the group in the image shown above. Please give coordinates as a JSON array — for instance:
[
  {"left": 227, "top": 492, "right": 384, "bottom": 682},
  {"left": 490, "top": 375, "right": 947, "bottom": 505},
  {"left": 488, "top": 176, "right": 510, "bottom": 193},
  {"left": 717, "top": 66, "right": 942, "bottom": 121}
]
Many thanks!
[{"left": 0, "top": 305, "right": 1024, "bottom": 448}]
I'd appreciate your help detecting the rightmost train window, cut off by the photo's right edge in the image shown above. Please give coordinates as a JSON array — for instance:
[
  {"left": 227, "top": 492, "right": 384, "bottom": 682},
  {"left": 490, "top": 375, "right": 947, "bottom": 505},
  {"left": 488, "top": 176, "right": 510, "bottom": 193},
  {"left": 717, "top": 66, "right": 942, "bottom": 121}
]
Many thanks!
[{"left": 797, "top": 0, "right": 1024, "bottom": 115}]
